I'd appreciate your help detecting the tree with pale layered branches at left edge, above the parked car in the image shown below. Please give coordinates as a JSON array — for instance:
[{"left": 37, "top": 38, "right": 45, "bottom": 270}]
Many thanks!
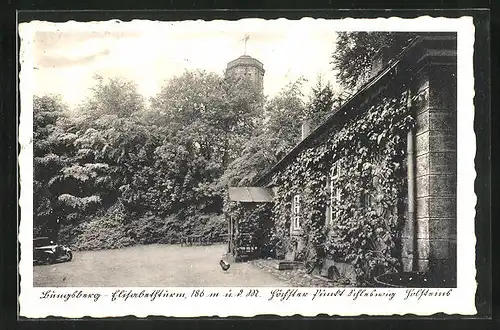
[{"left": 33, "top": 96, "right": 120, "bottom": 241}]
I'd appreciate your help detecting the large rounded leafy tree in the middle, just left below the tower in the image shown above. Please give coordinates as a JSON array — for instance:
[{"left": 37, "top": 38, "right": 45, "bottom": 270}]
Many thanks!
[{"left": 117, "top": 71, "right": 263, "bottom": 222}]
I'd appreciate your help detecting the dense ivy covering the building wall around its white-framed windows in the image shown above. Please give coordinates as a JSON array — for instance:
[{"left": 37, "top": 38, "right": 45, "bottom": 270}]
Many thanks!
[{"left": 272, "top": 86, "right": 414, "bottom": 280}]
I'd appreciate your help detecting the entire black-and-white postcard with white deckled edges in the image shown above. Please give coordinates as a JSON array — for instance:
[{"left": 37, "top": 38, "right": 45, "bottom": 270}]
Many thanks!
[{"left": 19, "top": 17, "right": 476, "bottom": 318}]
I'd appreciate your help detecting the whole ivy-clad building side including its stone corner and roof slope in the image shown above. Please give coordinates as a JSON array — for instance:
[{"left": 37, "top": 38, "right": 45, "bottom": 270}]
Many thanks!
[{"left": 257, "top": 35, "right": 457, "bottom": 284}]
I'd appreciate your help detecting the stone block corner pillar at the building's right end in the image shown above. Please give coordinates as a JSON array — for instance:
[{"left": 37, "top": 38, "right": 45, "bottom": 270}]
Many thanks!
[{"left": 407, "top": 57, "right": 457, "bottom": 276}]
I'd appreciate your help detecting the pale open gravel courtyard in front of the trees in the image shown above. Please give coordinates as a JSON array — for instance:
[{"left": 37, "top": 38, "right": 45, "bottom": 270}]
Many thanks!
[{"left": 33, "top": 244, "right": 287, "bottom": 287}]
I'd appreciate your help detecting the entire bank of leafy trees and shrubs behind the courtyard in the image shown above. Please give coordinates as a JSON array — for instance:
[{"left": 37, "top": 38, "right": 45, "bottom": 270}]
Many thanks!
[{"left": 34, "top": 71, "right": 333, "bottom": 249}]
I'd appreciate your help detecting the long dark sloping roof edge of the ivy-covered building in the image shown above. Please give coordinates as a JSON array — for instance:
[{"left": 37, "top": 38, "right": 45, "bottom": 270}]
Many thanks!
[{"left": 254, "top": 33, "right": 456, "bottom": 186}]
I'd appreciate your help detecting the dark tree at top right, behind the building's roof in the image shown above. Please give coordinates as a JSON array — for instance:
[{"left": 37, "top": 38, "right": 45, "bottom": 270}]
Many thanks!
[{"left": 332, "top": 32, "right": 415, "bottom": 89}]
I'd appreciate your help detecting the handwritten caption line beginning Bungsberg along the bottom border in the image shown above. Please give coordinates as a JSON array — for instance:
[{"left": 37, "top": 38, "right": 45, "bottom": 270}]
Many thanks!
[{"left": 40, "top": 288, "right": 453, "bottom": 302}]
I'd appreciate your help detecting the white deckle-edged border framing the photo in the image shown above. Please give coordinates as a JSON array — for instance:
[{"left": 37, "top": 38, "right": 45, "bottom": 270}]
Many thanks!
[{"left": 19, "top": 16, "right": 477, "bottom": 318}]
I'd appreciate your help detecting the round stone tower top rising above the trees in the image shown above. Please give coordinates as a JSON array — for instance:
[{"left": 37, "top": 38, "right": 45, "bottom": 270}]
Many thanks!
[{"left": 226, "top": 54, "right": 265, "bottom": 93}]
